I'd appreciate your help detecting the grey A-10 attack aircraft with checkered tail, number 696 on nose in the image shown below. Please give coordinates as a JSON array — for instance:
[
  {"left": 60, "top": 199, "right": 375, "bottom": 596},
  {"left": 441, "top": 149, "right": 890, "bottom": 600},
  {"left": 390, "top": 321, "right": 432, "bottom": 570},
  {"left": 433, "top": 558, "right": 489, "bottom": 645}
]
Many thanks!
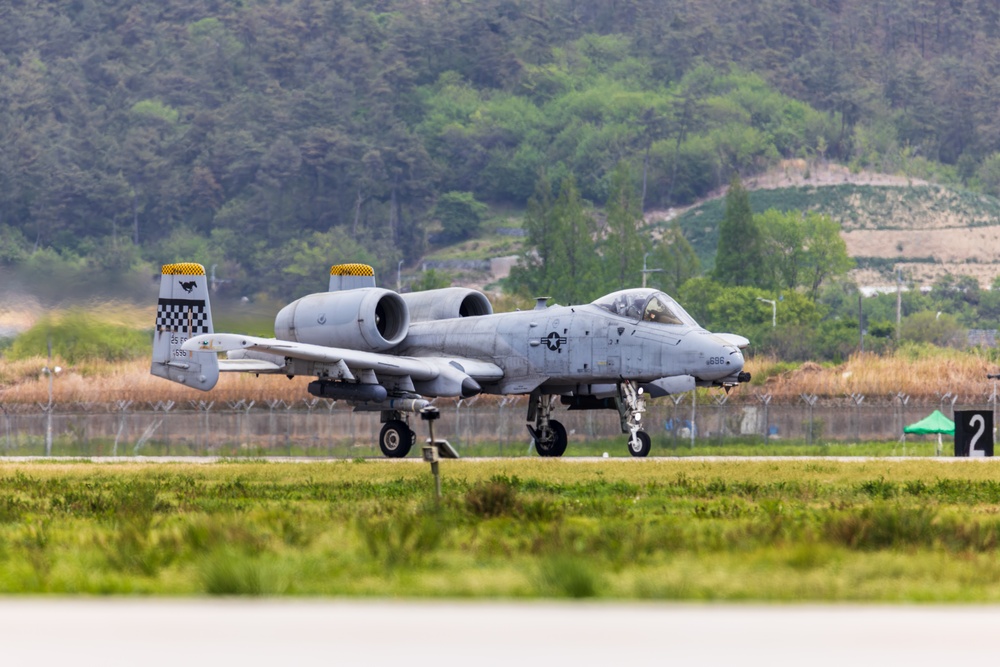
[{"left": 151, "top": 263, "right": 750, "bottom": 457}]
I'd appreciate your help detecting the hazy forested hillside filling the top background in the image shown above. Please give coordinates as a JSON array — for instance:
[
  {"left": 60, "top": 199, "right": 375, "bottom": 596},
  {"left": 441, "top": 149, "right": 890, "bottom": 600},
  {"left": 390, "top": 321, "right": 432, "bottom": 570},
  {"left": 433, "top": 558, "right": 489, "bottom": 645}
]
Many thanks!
[{"left": 0, "top": 0, "right": 1000, "bottom": 297}]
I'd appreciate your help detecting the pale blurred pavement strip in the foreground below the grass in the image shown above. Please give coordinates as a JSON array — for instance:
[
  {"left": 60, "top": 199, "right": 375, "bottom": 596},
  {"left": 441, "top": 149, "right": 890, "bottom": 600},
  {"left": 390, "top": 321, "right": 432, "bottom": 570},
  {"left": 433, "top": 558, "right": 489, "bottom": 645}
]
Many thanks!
[{"left": 0, "top": 598, "right": 1000, "bottom": 667}]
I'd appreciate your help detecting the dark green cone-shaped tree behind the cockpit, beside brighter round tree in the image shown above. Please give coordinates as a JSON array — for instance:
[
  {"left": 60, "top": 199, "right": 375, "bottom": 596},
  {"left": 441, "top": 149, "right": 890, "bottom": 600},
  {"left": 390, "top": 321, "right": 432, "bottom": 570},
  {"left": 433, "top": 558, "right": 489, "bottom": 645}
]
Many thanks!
[{"left": 713, "top": 175, "right": 765, "bottom": 287}]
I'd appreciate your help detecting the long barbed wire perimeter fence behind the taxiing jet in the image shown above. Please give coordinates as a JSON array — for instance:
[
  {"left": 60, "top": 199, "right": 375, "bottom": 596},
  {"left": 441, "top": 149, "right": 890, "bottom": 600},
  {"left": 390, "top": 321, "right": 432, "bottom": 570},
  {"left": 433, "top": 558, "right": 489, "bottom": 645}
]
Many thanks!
[{"left": 0, "top": 388, "right": 1000, "bottom": 456}]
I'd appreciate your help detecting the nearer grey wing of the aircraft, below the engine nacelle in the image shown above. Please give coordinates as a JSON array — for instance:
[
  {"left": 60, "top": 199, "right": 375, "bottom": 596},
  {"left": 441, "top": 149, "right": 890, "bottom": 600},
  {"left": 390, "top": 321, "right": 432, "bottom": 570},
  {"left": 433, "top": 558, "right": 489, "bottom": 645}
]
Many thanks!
[{"left": 182, "top": 333, "right": 503, "bottom": 382}]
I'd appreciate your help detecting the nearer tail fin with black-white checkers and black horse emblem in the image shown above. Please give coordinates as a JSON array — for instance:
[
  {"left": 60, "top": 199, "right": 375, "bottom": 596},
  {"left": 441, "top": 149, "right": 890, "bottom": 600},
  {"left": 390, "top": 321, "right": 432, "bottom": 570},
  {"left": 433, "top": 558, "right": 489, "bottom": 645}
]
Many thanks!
[{"left": 150, "top": 263, "right": 219, "bottom": 391}]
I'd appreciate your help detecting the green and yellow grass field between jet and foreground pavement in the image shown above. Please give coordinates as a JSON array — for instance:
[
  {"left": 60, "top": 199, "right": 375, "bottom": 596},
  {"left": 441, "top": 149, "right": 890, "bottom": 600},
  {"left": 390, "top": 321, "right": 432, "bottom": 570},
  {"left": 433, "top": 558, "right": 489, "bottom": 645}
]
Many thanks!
[{"left": 0, "top": 459, "right": 1000, "bottom": 602}]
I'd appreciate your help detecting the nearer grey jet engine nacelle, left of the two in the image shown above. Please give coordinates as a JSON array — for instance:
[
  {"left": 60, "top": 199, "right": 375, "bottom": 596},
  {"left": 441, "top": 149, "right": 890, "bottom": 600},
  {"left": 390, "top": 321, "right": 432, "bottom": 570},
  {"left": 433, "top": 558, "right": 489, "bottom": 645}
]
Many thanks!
[{"left": 274, "top": 287, "right": 410, "bottom": 352}]
